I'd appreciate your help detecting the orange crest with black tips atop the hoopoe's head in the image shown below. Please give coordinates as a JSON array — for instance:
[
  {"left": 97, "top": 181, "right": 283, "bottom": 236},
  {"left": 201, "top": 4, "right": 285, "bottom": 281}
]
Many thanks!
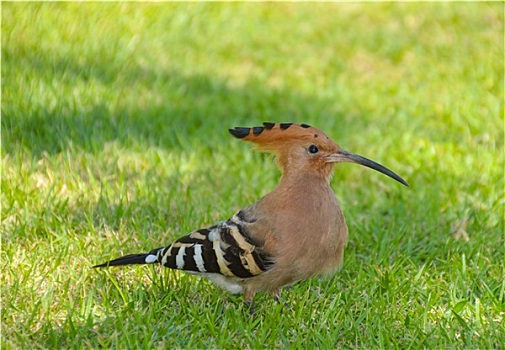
[{"left": 229, "top": 122, "right": 328, "bottom": 151}]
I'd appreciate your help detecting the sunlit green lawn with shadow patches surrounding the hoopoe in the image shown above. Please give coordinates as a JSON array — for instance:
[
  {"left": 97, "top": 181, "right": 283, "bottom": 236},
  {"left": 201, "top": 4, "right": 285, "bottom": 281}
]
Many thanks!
[{"left": 1, "top": 3, "right": 505, "bottom": 349}]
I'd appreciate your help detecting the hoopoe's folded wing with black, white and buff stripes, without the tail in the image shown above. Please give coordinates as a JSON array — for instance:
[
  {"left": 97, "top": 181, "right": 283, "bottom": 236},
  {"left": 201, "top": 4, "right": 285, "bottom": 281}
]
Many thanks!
[{"left": 157, "top": 212, "right": 272, "bottom": 278}]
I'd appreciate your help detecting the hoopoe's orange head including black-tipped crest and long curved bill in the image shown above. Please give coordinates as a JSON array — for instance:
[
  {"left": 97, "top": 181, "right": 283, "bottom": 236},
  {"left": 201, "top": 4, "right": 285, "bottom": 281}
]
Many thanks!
[{"left": 229, "top": 123, "right": 408, "bottom": 186}]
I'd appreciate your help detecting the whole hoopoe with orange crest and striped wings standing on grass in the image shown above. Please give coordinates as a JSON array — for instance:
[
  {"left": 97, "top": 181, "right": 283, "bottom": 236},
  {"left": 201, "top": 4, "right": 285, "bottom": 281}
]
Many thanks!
[{"left": 94, "top": 123, "right": 408, "bottom": 312}]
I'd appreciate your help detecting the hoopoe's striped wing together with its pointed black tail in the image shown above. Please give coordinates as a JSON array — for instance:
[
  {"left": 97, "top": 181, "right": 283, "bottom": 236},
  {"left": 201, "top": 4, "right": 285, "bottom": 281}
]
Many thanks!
[{"left": 94, "top": 211, "right": 273, "bottom": 293}]
